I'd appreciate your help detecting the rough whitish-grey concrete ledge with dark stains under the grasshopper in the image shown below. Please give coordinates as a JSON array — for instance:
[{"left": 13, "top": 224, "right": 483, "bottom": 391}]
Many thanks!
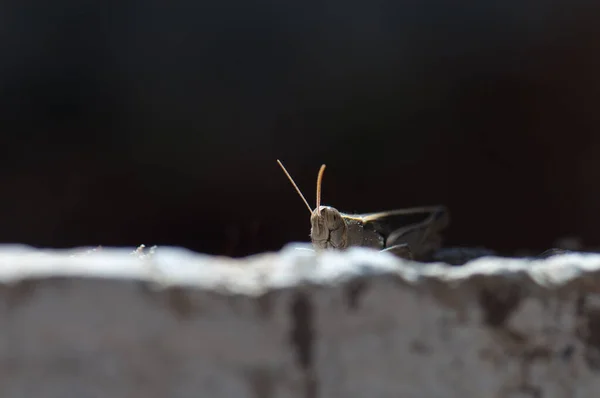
[{"left": 0, "top": 245, "right": 600, "bottom": 398}]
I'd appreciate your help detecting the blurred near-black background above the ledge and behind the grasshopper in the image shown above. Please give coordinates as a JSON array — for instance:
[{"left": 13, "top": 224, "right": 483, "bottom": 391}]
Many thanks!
[{"left": 0, "top": 0, "right": 600, "bottom": 256}]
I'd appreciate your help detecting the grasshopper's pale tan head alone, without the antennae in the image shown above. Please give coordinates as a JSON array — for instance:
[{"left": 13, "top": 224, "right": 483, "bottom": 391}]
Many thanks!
[{"left": 310, "top": 206, "right": 348, "bottom": 249}]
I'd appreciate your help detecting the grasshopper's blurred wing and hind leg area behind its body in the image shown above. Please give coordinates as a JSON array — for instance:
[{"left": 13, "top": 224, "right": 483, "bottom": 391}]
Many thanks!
[{"left": 357, "top": 206, "right": 450, "bottom": 257}]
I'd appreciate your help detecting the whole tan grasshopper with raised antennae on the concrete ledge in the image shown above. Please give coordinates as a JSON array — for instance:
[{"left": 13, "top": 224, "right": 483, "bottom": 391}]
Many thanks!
[{"left": 277, "top": 160, "right": 450, "bottom": 260}]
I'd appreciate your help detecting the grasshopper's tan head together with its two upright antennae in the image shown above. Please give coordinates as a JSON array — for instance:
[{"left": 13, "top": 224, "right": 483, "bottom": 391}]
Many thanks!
[{"left": 277, "top": 160, "right": 348, "bottom": 249}]
